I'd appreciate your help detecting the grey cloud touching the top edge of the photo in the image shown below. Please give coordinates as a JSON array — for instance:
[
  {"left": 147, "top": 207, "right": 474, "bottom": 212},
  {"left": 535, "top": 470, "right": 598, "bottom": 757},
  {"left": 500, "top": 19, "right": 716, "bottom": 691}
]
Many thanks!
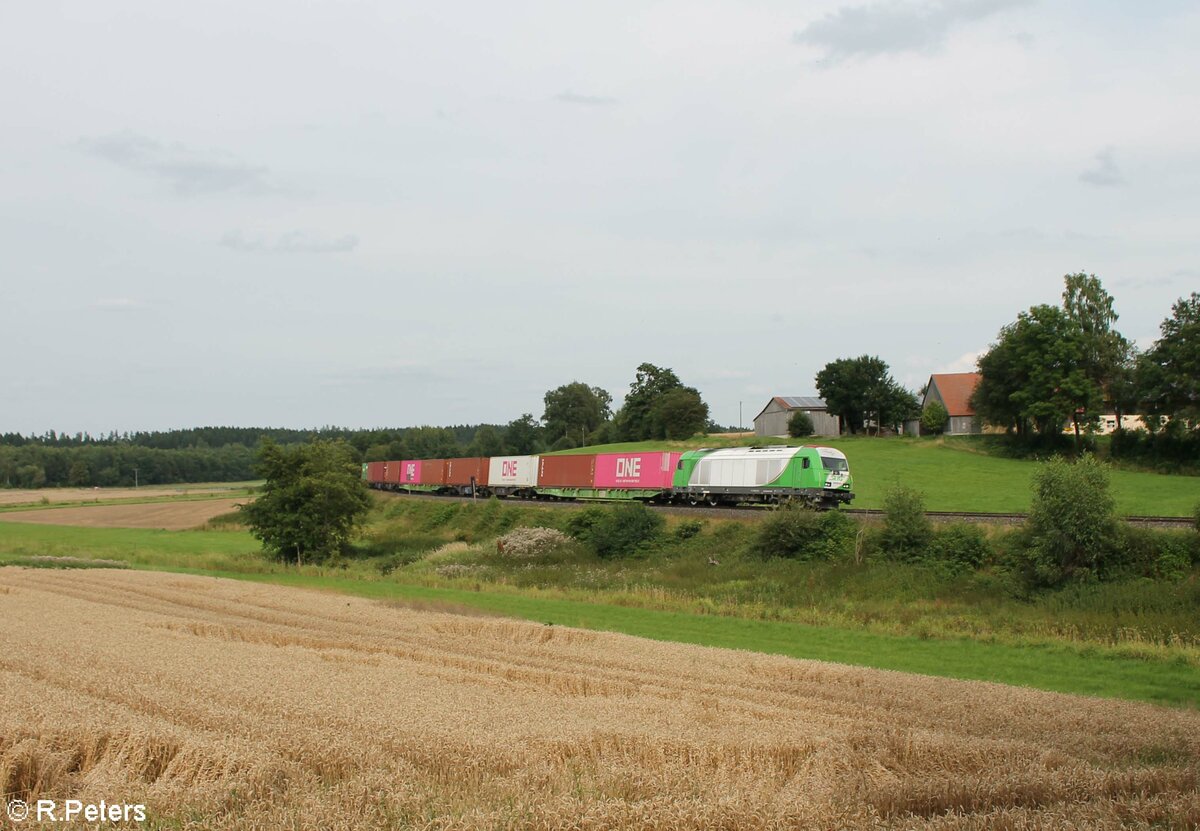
[{"left": 792, "top": 0, "right": 1028, "bottom": 61}]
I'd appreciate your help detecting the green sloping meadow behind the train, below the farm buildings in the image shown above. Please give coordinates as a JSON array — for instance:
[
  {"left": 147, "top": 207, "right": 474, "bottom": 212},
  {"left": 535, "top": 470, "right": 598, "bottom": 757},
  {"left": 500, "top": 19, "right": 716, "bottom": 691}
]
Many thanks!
[{"left": 552, "top": 436, "right": 1200, "bottom": 516}]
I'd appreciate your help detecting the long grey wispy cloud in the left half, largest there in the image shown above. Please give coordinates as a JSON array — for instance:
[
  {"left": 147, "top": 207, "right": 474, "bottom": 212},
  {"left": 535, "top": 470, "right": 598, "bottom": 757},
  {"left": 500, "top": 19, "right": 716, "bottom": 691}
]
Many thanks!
[{"left": 78, "top": 131, "right": 282, "bottom": 196}]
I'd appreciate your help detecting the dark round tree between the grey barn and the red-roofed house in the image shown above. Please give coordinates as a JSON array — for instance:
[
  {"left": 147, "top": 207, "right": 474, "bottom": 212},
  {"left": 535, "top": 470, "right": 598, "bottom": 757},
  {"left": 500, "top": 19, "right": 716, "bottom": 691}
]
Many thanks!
[{"left": 816, "top": 355, "right": 919, "bottom": 434}]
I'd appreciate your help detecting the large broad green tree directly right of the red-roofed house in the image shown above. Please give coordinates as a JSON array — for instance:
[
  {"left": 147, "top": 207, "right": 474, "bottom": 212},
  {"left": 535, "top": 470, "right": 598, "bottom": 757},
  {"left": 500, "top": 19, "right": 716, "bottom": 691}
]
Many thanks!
[{"left": 971, "top": 305, "right": 1102, "bottom": 435}]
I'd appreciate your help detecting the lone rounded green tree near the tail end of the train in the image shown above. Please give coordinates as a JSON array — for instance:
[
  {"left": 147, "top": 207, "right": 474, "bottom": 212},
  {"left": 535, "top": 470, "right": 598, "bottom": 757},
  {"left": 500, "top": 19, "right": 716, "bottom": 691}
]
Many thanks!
[{"left": 240, "top": 438, "right": 371, "bottom": 564}]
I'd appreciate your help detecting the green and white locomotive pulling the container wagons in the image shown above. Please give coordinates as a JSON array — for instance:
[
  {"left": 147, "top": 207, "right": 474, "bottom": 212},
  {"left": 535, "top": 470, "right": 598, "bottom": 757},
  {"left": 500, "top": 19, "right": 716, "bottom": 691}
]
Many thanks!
[{"left": 672, "top": 447, "right": 854, "bottom": 508}]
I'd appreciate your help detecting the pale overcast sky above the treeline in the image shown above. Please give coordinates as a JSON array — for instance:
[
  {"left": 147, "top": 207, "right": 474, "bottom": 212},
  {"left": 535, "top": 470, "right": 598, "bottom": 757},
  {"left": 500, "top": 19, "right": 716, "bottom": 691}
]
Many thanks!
[{"left": 0, "top": 0, "right": 1200, "bottom": 434}]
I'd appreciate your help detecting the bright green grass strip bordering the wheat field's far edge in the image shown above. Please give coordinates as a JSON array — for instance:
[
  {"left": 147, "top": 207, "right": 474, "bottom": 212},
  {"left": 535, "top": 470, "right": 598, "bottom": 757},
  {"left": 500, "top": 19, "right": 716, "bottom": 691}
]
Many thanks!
[{"left": 0, "top": 518, "right": 1200, "bottom": 706}]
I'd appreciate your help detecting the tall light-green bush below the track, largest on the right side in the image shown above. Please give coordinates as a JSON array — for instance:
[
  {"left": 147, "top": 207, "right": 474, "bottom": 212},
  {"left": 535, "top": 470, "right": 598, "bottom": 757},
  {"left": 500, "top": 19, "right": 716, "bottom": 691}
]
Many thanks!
[{"left": 1024, "top": 455, "right": 1118, "bottom": 586}]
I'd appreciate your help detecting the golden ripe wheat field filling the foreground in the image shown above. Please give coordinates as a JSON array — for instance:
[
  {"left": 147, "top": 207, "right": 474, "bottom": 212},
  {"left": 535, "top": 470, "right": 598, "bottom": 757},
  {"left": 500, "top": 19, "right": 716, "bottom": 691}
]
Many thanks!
[{"left": 0, "top": 568, "right": 1200, "bottom": 831}]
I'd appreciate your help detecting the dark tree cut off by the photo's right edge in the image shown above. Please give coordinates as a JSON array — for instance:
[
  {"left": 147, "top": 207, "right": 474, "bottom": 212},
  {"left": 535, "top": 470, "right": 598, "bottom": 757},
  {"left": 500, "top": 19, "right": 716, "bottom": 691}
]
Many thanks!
[{"left": 1138, "top": 292, "right": 1200, "bottom": 430}]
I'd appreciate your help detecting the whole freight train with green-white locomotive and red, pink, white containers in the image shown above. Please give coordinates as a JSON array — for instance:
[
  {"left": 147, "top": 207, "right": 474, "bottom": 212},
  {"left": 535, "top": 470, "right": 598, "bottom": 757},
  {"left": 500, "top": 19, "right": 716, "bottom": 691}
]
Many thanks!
[{"left": 362, "top": 447, "right": 854, "bottom": 508}]
